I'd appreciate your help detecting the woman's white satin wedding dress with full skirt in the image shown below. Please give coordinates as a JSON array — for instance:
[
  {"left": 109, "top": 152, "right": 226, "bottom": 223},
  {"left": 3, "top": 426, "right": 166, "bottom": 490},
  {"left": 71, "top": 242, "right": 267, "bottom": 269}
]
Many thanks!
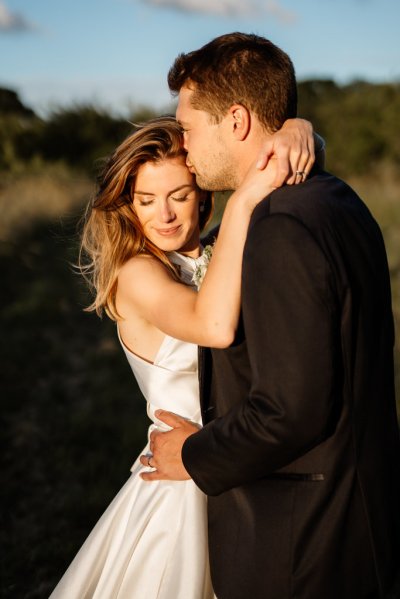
[{"left": 50, "top": 252, "right": 214, "bottom": 599}]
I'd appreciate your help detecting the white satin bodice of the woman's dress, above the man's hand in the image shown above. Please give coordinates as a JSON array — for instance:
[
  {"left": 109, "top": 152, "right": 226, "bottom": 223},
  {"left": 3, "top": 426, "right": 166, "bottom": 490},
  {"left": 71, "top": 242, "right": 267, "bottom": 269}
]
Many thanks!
[{"left": 118, "top": 252, "right": 206, "bottom": 428}]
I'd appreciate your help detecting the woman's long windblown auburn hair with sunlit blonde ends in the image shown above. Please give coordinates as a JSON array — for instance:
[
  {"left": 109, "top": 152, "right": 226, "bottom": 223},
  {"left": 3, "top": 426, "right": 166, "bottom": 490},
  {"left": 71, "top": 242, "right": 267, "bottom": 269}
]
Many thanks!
[{"left": 79, "top": 116, "right": 213, "bottom": 320}]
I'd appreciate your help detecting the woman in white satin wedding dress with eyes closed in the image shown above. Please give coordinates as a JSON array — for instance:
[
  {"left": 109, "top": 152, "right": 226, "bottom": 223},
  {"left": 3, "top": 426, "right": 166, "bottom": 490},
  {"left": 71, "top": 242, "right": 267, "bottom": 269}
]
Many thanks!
[{"left": 51, "top": 117, "right": 318, "bottom": 599}]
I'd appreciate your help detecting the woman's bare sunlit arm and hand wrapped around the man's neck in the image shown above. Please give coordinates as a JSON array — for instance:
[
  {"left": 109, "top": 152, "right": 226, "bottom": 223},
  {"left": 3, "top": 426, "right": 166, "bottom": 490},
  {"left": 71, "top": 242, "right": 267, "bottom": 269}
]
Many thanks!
[{"left": 118, "top": 123, "right": 314, "bottom": 347}]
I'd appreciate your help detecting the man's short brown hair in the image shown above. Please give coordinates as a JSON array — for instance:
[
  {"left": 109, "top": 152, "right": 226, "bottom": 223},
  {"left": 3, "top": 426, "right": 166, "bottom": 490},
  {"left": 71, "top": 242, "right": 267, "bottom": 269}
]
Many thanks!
[{"left": 168, "top": 33, "right": 297, "bottom": 133}]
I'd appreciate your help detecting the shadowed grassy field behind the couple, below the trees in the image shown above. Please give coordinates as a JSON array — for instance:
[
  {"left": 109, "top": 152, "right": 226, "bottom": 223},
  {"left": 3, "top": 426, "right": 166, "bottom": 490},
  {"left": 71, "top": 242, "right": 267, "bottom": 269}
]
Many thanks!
[{"left": 0, "top": 165, "right": 400, "bottom": 599}]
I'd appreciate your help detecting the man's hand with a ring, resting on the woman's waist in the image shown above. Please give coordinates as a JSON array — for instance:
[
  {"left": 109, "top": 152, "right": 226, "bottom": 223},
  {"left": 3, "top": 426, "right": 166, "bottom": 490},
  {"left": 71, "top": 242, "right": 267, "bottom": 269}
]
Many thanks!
[{"left": 140, "top": 410, "right": 199, "bottom": 481}]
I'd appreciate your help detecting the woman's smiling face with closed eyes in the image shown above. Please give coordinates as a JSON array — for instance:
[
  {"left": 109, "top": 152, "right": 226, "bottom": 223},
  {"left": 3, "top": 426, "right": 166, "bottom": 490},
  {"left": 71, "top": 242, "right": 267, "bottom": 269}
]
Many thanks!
[{"left": 133, "top": 157, "right": 201, "bottom": 257}]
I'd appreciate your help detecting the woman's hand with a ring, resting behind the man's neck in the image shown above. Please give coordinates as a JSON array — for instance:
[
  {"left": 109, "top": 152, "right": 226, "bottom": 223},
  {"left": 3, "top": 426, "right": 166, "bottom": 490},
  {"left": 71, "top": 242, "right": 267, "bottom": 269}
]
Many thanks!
[{"left": 257, "top": 119, "right": 315, "bottom": 187}]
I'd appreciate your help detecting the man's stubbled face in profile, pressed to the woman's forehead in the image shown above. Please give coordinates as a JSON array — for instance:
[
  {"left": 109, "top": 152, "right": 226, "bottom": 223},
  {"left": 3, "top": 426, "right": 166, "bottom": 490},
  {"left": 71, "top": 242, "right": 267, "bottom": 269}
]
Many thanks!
[{"left": 176, "top": 86, "right": 236, "bottom": 191}]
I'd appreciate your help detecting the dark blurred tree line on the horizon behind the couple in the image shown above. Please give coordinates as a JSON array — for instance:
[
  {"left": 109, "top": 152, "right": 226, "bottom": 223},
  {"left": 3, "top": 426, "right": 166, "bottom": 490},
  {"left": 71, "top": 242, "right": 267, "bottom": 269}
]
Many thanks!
[{"left": 0, "top": 80, "right": 400, "bottom": 177}]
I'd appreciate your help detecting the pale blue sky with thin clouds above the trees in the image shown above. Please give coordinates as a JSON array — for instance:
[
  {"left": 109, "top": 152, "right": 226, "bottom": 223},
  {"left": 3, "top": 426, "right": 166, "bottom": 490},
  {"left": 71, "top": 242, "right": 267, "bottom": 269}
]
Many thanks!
[{"left": 0, "top": 0, "right": 400, "bottom": 114}]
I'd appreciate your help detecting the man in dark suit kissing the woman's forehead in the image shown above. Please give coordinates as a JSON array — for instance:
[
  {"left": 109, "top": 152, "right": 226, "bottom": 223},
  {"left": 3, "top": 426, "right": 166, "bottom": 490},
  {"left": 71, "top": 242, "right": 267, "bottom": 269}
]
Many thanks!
[{"left": 143, "top": 33, "right": 400, "bottom": 599}]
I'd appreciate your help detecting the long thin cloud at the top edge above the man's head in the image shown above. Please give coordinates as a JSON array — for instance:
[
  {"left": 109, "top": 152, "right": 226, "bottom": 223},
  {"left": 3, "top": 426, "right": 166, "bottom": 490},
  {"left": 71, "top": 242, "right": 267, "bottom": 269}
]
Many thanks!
[{"left": 143, "top": 0, "right": 297, "bottom": 23}]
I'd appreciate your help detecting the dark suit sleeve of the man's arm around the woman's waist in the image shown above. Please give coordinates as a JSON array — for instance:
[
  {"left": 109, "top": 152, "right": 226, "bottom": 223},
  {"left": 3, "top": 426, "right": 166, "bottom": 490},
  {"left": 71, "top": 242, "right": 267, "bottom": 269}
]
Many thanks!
[{"left": 182, "top": 214, "right": 340, "bottom": 495}]
